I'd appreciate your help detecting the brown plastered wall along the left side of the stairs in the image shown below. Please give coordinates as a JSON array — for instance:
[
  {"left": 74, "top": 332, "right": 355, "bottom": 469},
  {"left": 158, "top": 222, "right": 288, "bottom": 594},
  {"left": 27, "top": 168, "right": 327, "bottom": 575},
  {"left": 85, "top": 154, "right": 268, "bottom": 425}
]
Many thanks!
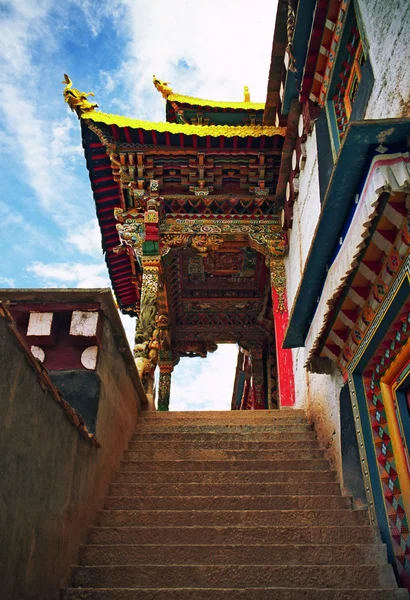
[{"left": 0, "top": 300, "right": 146, "bottom": 600}]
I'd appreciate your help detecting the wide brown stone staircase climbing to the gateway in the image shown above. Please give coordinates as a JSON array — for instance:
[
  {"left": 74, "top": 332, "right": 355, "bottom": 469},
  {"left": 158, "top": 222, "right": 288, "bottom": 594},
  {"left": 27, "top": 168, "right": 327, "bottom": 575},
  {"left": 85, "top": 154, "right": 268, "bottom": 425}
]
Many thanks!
[{"left": 62, "top": 410, "right": 408, "bottom": 600}]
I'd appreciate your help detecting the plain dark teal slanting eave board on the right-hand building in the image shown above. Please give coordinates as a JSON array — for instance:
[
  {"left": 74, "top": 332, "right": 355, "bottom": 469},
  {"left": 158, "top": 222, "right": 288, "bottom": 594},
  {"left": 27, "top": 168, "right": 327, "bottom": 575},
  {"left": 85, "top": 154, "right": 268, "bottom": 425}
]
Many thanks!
[{"left": 283, "top": 119, "right": 410, "bottom": 348}]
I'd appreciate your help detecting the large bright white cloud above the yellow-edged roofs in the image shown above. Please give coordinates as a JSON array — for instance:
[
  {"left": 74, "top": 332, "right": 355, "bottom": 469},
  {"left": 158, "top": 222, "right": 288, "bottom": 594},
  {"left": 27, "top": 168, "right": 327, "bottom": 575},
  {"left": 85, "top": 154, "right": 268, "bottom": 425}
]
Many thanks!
[{"left": 102, "top": 0, "right": 277, "bottom": 120}]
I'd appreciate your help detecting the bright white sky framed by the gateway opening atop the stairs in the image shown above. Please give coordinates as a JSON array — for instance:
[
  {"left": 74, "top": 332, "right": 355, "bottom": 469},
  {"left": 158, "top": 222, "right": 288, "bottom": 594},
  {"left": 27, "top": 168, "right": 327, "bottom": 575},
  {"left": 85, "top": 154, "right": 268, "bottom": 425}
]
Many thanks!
[{"left": 170, "top": 344, "right": 238, "bottom": 410}]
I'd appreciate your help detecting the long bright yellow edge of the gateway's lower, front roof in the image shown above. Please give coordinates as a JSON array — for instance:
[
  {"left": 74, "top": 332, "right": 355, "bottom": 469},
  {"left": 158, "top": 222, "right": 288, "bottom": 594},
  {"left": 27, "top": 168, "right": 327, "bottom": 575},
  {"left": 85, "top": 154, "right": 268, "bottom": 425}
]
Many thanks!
[{"left": 81, "top": 111, "right": 286, "bottom": 138}]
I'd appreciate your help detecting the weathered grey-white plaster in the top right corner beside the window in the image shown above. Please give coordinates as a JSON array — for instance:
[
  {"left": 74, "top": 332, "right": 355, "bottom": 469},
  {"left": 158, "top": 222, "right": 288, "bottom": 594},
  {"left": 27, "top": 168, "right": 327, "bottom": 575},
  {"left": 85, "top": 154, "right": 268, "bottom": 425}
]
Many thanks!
[{"left": 357, "top": 0, "right": 410, "bottom": 119}]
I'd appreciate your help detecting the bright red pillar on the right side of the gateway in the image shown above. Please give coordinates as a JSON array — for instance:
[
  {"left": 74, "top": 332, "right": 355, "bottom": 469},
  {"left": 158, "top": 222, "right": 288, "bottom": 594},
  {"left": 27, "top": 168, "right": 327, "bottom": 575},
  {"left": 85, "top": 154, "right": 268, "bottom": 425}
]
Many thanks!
[{"left": 272, "top": 287, "right": 295, "bottom": 408}]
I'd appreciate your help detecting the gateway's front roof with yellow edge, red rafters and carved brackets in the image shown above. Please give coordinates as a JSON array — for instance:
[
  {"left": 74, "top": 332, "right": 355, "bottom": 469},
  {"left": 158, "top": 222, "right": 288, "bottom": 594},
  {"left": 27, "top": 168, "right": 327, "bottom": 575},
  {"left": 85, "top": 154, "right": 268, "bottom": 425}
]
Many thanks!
[{"left": 78, "top": 105, "right": 286, "bottom": 314}]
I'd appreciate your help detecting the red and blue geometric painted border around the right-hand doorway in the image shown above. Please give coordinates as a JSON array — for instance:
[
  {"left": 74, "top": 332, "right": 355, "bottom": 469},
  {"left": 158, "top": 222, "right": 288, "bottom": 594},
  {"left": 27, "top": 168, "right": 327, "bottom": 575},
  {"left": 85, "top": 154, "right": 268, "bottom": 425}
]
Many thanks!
[{"left": 363, "top": 304, "right": 410, "bottom": 584}]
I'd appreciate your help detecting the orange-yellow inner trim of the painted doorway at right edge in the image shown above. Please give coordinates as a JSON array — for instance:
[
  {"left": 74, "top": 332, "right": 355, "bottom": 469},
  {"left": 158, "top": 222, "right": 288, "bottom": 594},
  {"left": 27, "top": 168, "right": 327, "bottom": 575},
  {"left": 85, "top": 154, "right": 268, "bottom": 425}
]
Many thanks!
[{"left": 380, "top": 341, "right": 410, "bottom": 519}]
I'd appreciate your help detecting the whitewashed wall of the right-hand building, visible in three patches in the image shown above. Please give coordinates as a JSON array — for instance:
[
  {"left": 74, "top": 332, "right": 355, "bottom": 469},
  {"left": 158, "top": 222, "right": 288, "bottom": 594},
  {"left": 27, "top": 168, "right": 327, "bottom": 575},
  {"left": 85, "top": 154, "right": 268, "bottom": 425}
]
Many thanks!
[{"left": 285, "top": 0, "right": 410, "bottom": 481}]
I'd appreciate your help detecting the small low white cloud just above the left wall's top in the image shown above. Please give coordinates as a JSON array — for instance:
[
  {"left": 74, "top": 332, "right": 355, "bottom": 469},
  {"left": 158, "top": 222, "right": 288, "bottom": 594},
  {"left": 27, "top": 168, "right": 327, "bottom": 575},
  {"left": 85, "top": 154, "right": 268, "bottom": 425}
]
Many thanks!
[{"left": 27, "top": 262, "right": 110, "bottom": 288}]
